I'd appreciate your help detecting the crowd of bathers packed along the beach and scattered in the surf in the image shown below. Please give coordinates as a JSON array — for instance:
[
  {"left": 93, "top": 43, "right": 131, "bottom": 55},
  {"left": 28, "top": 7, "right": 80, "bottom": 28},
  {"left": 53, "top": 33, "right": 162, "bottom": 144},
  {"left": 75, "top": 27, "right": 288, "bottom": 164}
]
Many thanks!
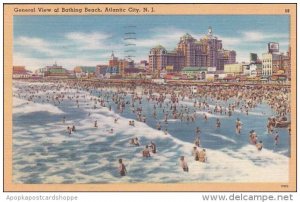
[{"left": 14, "top": 80, "right": 291, "bottom": 176}]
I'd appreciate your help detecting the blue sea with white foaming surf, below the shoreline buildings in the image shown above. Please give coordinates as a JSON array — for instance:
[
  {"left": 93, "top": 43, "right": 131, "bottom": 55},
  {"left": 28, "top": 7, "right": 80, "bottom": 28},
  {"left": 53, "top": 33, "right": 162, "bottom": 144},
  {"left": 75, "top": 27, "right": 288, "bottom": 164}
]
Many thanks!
[{"left": 12, "top": 81, "right": 290, "bottom": 184}]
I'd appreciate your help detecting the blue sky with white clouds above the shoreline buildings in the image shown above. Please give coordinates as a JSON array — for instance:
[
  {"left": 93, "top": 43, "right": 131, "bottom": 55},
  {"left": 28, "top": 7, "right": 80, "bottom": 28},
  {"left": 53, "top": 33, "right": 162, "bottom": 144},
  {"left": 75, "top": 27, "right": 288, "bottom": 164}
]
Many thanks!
[{"left": 13, "top": 15, "right": 289, "bottom": 70}]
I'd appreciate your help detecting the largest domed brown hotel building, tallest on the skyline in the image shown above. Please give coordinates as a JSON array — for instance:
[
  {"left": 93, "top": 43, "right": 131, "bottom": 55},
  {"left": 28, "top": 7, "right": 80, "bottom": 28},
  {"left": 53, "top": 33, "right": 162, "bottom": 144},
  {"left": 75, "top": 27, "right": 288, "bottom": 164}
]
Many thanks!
[{"left": 149, "top": 27, "right": 236, "bottom": 71}]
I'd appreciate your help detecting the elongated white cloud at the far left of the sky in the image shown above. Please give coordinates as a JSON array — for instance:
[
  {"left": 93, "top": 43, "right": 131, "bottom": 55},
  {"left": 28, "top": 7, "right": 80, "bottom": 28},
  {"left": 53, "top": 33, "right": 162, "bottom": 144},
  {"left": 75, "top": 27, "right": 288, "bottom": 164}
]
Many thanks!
[{"left": 14, "top": 36, "right": 62, "bottom": 56}]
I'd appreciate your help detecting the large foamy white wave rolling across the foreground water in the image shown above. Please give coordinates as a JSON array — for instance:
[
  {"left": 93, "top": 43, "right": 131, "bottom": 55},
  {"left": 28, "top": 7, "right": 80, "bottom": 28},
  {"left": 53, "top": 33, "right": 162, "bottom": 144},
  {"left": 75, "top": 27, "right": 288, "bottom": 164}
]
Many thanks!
[{"left": 13, "top": 81, "right": 289, "bottom": 183}]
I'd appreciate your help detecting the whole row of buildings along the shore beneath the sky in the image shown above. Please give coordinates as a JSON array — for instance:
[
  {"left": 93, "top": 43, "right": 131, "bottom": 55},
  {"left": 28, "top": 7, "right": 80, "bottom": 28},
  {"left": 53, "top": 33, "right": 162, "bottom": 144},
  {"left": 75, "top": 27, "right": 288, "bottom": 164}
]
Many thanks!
[{"left": 13, "top": 27, "right": 291, "bottom": 81}]
